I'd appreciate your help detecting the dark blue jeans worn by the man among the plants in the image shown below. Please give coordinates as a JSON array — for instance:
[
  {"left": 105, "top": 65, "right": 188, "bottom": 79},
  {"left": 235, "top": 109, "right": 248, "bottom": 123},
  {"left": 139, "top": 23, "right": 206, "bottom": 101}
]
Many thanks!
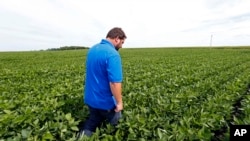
[{"left": 83, "top": 106, "right": 122, "bottom": 136}]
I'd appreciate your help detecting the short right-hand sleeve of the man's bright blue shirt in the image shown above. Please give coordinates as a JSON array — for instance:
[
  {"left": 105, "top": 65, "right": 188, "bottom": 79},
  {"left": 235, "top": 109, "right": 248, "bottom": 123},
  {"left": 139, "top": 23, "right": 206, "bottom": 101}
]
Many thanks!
[{"left": 107, "top": 55, "right": 123, "bottom": 82}]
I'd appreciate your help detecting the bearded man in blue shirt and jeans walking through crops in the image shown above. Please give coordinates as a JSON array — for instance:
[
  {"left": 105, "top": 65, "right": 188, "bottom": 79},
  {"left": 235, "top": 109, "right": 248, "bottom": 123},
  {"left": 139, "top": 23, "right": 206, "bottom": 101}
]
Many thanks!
[{"left": 80, "top": 27, "right": 127, "bottom": 136}]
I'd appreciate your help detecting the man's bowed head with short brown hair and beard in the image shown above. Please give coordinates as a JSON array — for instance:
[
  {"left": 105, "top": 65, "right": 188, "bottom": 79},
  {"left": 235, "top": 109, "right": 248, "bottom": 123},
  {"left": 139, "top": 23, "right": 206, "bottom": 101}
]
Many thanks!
[{"left": 106, "top": 27, "right": 127, "bottom": 50}]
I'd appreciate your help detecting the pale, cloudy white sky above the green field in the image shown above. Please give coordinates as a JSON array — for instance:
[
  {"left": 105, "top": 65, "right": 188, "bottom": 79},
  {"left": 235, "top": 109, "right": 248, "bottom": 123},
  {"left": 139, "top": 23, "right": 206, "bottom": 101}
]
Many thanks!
[{"left": 0, "top": 0, "right": 250, "bottom": 51}]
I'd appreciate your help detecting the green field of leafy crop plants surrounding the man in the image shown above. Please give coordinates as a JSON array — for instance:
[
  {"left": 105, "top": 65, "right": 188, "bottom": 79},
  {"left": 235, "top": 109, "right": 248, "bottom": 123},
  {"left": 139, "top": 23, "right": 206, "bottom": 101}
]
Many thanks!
[{"left": 0, "top": 47, "right": 250, "bottom": 141}]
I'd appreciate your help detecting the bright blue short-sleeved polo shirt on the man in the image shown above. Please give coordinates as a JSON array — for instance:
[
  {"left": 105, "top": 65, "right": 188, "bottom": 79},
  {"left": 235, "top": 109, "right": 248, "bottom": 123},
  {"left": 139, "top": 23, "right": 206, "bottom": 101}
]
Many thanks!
[{"left": 84, "top": 39, "right": 123, "bottom": 110}]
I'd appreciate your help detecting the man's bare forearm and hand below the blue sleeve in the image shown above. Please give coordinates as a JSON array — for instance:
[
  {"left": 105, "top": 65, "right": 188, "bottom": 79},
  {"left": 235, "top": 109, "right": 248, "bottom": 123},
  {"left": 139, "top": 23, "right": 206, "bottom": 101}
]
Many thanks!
[{"left": 109, "top": 82, "right": 123, "bottom": 112}]
